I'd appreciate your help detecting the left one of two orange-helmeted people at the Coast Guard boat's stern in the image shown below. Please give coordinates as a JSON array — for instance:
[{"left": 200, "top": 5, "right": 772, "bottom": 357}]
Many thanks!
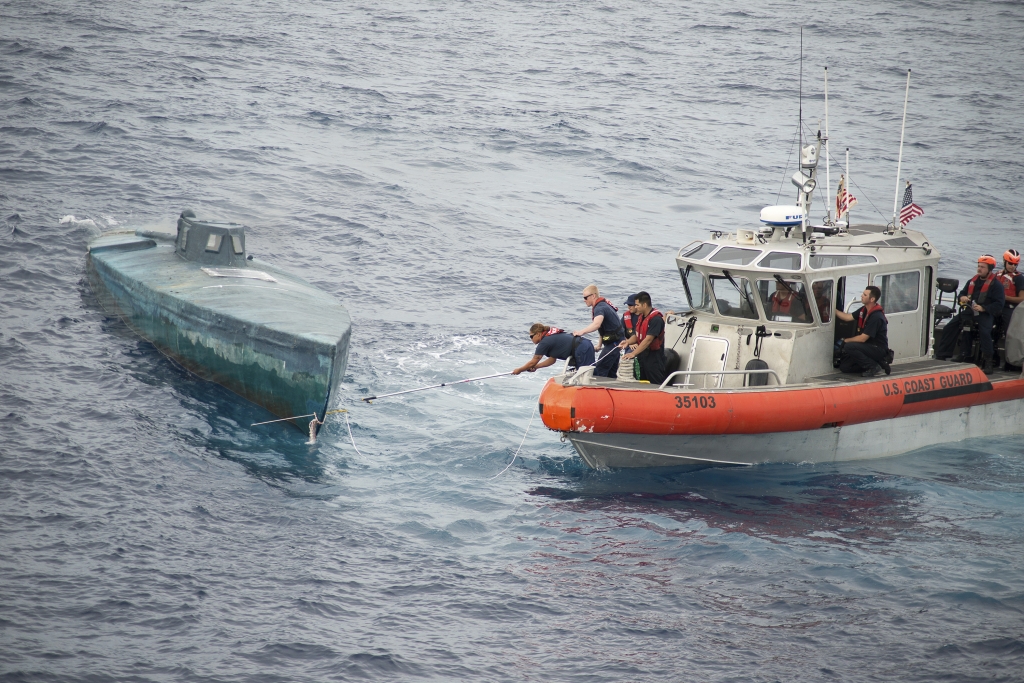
[{"left": 935, "top": 254, "right": 1006, "bottom": 373}]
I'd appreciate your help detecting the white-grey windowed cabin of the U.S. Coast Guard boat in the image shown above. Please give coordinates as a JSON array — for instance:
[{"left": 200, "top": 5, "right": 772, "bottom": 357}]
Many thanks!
[{"left": 666, "top": 222, "right": 939, "bottom": 388}]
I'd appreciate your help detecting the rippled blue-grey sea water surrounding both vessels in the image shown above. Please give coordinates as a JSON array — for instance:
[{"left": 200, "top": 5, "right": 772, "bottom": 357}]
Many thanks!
[{"left": 0, "top": 0, "right": 1024, "bottom": 683}]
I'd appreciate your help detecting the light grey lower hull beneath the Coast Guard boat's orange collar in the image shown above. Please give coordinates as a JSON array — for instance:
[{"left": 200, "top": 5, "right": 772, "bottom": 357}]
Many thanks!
[{"left": 566, "top": 399, "right": 1024, "bottom": 469}]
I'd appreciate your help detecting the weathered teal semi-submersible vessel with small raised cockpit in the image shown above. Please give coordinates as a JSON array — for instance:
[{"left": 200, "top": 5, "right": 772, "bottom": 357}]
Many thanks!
[{"left": 87, "top": 210, "right": 351, "bottom": 435}]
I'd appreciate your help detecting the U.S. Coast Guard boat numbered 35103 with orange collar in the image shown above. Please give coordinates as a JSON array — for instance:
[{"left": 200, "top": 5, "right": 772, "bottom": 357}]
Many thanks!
[{"left": 540, "top": 120, "right": 1024, "bottom": 468}]
